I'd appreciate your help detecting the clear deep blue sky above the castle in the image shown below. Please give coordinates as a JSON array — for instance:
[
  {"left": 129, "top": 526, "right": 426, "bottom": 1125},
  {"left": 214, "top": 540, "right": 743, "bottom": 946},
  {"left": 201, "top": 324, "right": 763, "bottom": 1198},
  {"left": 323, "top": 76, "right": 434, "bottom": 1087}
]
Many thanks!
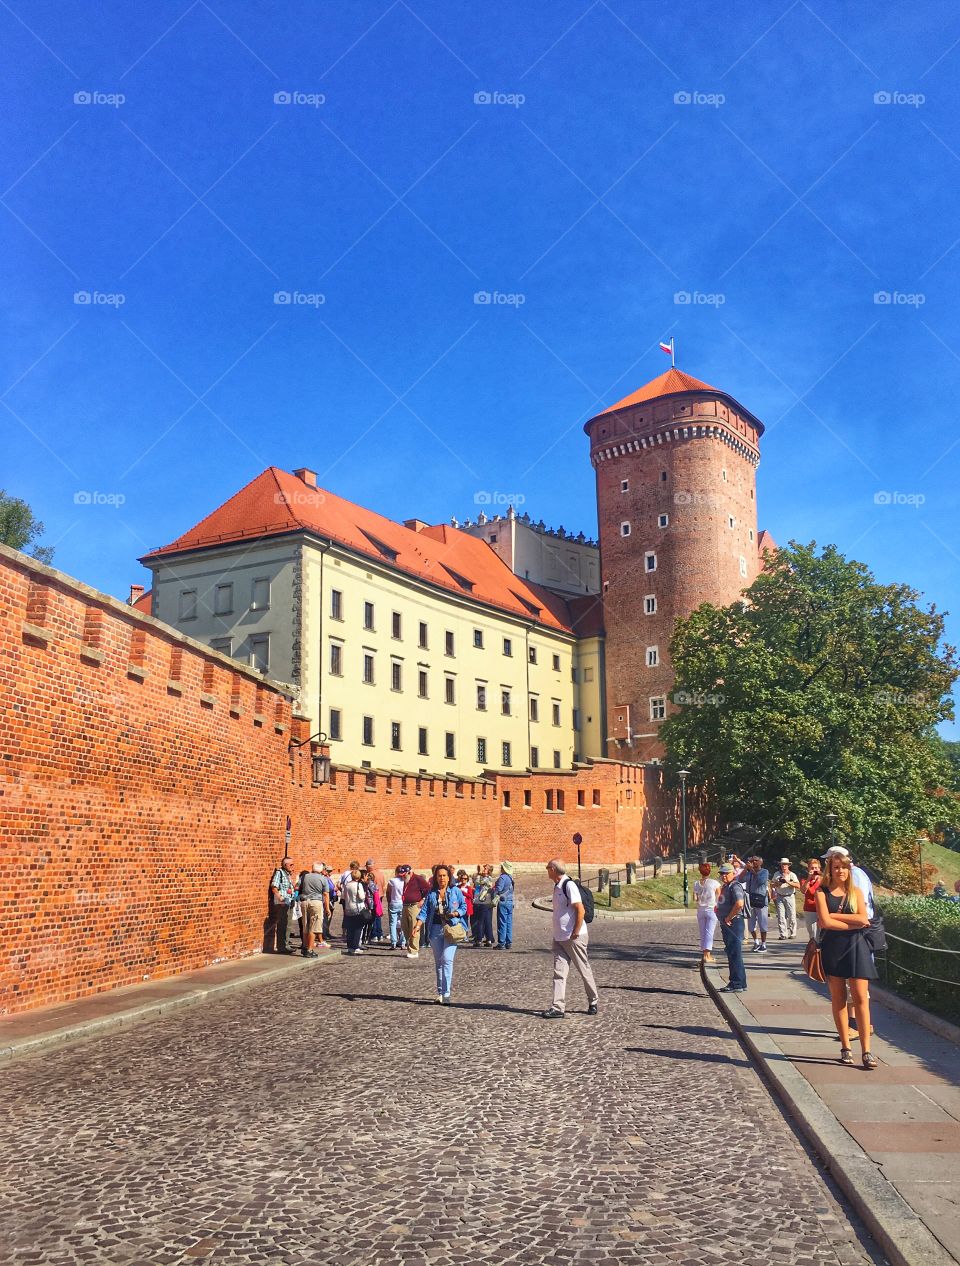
[{"left": 0, "top": 0, "right": 960, "bottom": 736}]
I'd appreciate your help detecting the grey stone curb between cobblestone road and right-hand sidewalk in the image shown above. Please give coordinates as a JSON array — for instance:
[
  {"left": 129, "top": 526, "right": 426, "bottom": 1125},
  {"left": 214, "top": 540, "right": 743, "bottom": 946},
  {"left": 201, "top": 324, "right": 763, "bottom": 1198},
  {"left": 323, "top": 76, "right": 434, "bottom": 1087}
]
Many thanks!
[{"left": 700, "top": 963, "right": 956, "bottom": 1266}]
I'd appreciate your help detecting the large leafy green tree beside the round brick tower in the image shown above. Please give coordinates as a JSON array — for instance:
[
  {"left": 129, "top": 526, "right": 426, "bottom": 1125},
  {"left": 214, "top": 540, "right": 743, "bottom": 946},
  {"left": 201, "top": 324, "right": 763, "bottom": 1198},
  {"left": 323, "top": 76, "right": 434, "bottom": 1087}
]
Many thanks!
[{"left": 661, "top": 542, "right": 957, "bottom": 865}]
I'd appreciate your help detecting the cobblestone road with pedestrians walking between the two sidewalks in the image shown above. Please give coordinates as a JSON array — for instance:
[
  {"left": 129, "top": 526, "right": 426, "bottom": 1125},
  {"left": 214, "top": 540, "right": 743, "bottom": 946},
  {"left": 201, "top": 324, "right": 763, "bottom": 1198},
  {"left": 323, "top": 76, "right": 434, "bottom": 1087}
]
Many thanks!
[{"left": 0, "top": 891, "right": 871, "bottom": 1266}]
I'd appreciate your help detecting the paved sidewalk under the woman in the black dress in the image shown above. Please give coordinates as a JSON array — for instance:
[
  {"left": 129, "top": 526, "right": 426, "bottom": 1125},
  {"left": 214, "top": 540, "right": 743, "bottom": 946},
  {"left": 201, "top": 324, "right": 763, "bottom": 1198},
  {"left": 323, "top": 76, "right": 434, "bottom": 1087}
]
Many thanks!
[{"left": 704, "top": 934, "right": 960, "bottom": 1266}]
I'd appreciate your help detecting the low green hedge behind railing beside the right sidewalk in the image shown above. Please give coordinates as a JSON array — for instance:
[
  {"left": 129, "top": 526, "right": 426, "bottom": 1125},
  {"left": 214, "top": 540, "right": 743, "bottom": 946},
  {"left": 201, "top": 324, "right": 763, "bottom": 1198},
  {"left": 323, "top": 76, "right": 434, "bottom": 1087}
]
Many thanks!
[{"left": 879, "top": 896, "right": 960, "bottom": 1023}]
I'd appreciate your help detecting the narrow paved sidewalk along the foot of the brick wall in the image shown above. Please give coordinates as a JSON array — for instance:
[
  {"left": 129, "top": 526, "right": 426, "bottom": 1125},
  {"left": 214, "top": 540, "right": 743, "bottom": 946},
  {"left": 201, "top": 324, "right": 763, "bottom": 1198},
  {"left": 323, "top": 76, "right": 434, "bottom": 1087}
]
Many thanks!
[{"left": 0, "top": 950, "right": 341, "bottom": 1061}]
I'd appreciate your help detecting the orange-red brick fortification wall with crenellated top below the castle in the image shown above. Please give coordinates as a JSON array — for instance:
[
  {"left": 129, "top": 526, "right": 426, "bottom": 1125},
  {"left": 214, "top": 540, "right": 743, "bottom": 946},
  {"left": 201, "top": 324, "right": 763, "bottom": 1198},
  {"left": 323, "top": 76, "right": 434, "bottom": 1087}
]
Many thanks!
[{"left": 0, "top": 546, "right": 709, "bottom": 1014}]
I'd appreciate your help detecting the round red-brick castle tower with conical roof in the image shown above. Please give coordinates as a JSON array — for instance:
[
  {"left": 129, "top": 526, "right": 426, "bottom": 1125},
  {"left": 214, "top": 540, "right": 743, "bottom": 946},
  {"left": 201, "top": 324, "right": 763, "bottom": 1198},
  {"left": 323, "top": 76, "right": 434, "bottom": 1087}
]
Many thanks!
[{"left": 584, "top": 368, "right": 764, "bottom": 761}]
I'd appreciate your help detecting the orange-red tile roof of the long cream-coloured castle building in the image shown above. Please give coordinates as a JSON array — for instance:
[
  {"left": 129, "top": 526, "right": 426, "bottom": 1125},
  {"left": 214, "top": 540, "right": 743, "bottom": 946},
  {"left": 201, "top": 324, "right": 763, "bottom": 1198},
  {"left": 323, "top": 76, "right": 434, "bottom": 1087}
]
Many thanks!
[{"left": 141, "top": 466, "right": 580, "bottom": 633}]
